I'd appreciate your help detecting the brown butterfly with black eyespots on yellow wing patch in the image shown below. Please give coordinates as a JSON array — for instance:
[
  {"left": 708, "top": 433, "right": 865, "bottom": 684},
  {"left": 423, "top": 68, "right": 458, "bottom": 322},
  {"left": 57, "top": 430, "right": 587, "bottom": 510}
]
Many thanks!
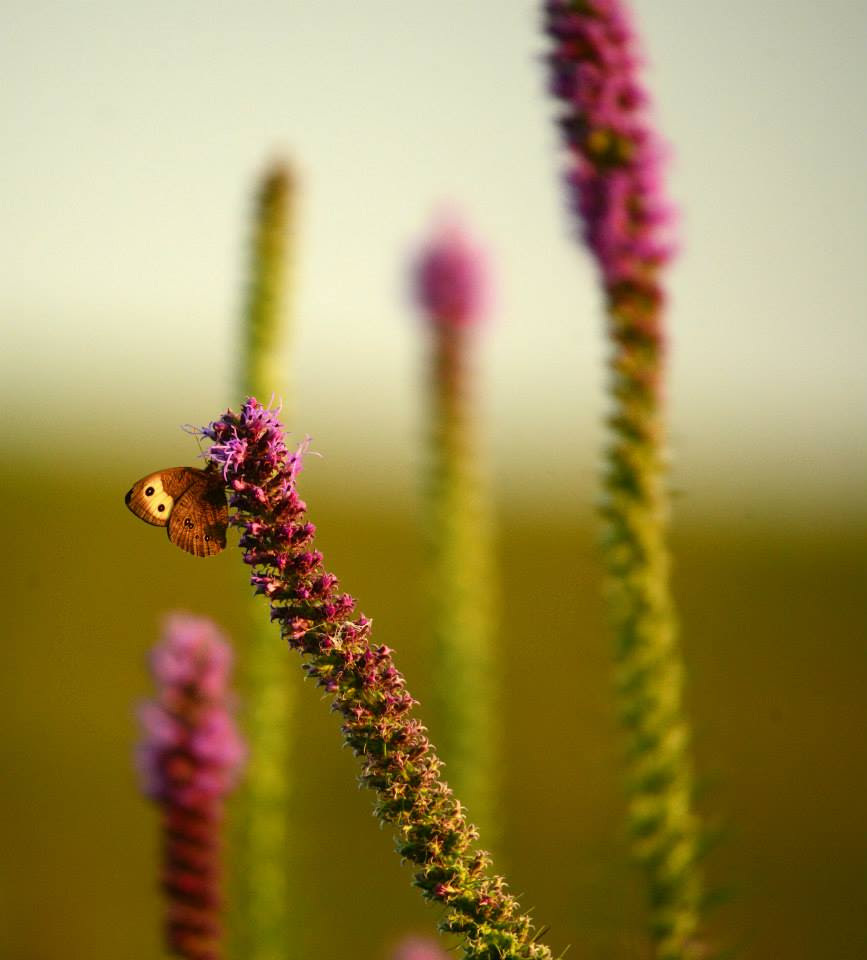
[{"left": 125, "top": 467, "right": 229, "bottom": 557}]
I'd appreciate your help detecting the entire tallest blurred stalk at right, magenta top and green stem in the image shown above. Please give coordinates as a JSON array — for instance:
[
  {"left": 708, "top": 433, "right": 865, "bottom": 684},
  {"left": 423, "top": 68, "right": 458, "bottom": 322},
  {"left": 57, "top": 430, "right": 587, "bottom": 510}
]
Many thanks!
[{"left": 545, "top": 0, "right": 702, "bottom": 960}]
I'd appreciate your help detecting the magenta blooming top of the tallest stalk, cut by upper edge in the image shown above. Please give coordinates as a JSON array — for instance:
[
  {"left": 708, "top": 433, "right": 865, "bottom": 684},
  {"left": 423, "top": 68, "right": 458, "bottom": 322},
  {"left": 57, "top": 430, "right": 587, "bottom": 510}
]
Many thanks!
[{"left": 545, "top": 0, "right": 674, "bottom": 287}]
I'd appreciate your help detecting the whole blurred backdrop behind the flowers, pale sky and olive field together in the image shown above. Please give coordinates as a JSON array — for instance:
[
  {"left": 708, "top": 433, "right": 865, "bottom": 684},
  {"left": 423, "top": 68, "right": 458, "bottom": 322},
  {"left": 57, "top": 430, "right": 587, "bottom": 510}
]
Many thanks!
[{"left": 0, "top": 0, "right": 867, "bottom": 960}]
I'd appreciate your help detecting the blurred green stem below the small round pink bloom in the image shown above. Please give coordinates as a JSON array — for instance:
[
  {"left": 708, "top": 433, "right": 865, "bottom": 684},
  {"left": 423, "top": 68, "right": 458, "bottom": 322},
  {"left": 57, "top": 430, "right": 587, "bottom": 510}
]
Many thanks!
[{"left": 427, "top": 324, "right": 497, "bottom": 844}]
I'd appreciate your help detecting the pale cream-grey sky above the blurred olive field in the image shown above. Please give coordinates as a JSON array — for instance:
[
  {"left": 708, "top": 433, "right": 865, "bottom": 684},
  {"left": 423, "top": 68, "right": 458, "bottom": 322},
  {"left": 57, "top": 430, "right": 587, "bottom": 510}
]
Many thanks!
[{"left": 0, "top": 0, "right": 867, "bottom": 512}]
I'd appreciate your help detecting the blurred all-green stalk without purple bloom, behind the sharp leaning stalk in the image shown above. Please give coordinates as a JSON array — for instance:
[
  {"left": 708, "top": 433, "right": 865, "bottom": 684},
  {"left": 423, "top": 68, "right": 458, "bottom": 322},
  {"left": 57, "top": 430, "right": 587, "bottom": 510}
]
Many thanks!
[{"left": 230, "top": 163, "right": 297, "bottom": 960}]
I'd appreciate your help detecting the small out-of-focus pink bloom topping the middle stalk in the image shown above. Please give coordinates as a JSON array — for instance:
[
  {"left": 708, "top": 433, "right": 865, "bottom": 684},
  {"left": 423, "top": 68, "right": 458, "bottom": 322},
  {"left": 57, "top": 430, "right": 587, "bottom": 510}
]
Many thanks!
[{"left": 415, "top": 215, "right": 488, "bottom": 329}]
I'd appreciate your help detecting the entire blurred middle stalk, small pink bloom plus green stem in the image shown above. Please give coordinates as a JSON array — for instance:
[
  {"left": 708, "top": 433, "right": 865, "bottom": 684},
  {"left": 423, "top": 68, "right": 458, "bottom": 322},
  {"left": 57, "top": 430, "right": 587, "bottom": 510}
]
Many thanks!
[{"left": 414, "top": 220, "right": 496, "bottom": 842}]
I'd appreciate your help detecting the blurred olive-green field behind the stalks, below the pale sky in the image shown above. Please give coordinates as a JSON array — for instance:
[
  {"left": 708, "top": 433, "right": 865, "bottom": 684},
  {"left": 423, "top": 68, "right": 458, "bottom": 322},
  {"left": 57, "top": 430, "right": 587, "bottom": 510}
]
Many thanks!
[{"left": 0, "top": 466, "right": 867, "bottom": 960}]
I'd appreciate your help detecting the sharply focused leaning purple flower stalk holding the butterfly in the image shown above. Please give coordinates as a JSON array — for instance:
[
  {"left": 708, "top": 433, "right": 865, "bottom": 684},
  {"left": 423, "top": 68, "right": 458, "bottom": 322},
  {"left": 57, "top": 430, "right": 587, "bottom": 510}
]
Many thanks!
[{"left": 202, "top": 399, "right": 551, "bottom": 960}]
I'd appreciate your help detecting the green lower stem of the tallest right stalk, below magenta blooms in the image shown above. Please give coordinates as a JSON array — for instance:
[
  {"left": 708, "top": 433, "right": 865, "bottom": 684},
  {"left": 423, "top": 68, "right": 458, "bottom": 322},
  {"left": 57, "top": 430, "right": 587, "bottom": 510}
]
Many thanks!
[{"left": 603, "top": 279, "right": 702, "bottom": 960}]
